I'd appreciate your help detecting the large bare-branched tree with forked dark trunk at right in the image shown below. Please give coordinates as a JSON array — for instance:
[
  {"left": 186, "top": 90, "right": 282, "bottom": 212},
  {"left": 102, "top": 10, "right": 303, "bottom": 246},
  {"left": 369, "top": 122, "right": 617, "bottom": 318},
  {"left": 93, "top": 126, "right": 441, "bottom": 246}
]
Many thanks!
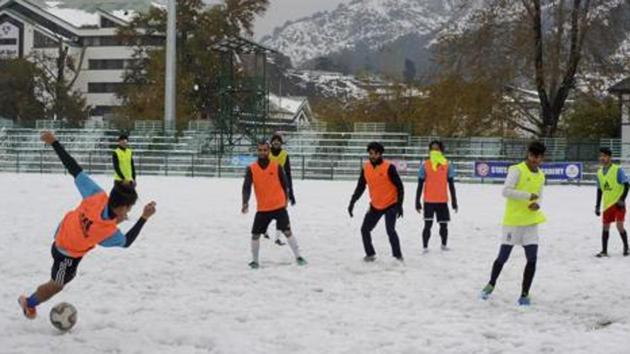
[{"left": 438, "top": 0, "right": 630, "bottom": 137}]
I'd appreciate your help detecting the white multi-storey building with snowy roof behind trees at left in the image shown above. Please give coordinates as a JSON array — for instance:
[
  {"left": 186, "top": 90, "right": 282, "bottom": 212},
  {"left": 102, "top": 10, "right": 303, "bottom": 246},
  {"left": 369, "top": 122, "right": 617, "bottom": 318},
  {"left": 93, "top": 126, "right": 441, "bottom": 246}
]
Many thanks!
[{"left": 0, "top": 0, "right": 164, "bottom": 118}]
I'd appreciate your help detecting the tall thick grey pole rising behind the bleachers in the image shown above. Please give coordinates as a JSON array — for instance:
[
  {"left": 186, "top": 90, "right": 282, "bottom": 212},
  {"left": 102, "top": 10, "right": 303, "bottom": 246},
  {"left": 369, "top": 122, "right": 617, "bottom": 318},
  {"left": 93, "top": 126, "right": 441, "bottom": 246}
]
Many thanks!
[{"left": 164, "top": 0, "right": 177, "bottom": 132}]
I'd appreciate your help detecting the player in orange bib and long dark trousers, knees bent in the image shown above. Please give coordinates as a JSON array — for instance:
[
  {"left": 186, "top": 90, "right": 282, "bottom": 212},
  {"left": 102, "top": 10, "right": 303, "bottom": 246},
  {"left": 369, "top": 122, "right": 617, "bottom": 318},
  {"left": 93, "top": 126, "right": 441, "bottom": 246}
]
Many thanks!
[{"left": 348, "top": 142, "right": 405, "bottom": 262}]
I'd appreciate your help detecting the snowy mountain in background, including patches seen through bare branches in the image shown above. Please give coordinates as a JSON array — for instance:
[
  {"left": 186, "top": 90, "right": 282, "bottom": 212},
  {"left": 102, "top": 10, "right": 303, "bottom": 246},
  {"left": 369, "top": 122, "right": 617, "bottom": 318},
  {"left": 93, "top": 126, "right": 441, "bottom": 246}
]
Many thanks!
[{"left": 262, "top": 0, "right": 630, "bottom": 79}]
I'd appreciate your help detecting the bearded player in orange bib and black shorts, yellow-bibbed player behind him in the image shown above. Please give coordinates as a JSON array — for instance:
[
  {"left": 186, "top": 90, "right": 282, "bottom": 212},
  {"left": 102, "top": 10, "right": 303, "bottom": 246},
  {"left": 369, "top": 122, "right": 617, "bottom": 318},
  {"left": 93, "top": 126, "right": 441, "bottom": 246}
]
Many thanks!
[{"left": 241, "top": 142, "right": 306, "bottom": 269}]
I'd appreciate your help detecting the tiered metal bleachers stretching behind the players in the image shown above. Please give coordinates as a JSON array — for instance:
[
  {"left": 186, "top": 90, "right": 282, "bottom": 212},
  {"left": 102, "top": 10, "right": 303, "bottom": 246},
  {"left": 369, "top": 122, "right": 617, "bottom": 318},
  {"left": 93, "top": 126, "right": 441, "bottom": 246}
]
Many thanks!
[{"left": 0, "top": 127, "right": 630, "bottom": 183}]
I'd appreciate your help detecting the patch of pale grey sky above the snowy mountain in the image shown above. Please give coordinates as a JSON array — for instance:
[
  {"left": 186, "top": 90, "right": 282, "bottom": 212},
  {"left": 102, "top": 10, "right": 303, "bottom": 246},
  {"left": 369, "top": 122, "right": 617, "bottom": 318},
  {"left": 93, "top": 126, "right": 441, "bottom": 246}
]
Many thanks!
[{"left": 255, "top": 0, "right": 349, "bottom": 38}]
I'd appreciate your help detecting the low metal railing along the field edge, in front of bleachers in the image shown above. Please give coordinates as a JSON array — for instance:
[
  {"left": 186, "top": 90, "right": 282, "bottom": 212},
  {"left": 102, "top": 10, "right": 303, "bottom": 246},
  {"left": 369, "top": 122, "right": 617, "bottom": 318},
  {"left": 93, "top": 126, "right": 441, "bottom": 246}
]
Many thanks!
[{"left": 0, "top": 149, "right": 616, "bottom": 184}]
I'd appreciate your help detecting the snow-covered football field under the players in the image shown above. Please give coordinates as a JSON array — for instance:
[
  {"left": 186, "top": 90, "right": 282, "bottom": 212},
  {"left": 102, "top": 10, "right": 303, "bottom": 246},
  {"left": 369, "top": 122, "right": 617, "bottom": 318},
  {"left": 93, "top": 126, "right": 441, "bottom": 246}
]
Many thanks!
[{"left": 0, "top": 174, "right": 630, "bottom": 354}]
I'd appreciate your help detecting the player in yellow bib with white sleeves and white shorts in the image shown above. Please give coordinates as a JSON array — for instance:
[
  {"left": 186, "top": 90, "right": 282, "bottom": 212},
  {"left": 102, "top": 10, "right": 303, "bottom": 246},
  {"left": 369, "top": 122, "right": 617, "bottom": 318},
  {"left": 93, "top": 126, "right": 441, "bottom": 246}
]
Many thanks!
[{"left": 481, "top": 142, "right": 547, "bottom": 306}]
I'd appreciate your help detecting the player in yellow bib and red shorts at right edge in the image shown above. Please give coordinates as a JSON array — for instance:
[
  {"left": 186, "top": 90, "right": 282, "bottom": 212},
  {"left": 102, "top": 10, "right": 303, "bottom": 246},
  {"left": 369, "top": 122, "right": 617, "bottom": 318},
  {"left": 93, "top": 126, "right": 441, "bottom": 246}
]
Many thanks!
[{"left": 595, "top": 148, "right": 630, "bottom": 257}]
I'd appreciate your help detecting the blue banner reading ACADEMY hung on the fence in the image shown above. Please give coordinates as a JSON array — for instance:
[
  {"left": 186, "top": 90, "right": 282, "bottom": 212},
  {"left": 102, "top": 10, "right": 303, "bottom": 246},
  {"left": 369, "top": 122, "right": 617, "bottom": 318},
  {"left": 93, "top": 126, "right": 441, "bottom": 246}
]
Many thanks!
[{"left": 475, "top": 161, "right": 584, "bottom": 181}]
